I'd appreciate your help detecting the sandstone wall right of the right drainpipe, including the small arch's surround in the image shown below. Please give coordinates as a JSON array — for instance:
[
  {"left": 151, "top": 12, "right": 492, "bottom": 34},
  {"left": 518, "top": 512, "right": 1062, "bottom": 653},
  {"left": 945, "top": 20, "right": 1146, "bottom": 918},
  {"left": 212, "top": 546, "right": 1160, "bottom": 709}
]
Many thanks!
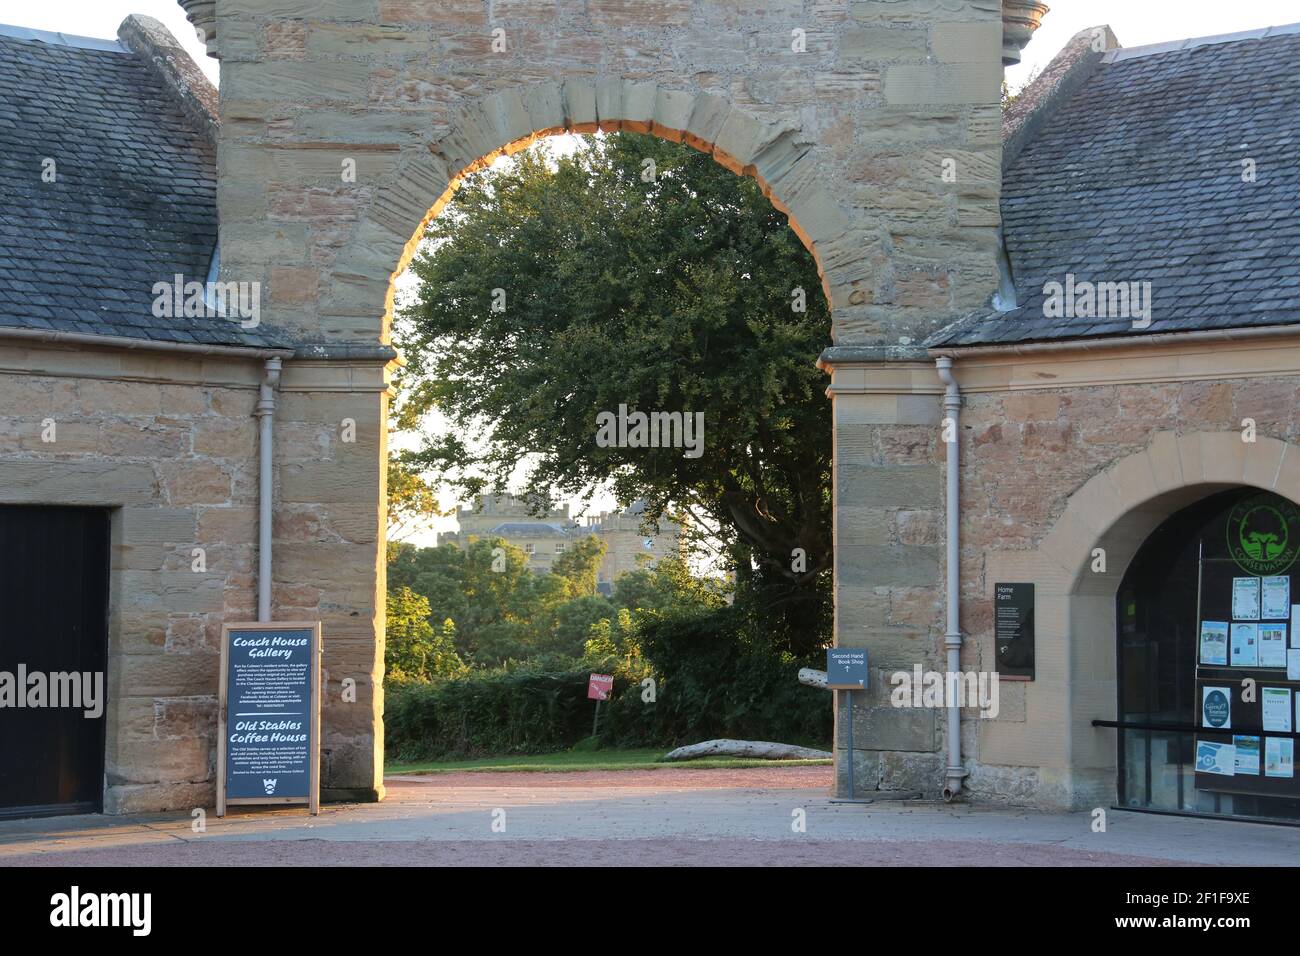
[{"left": 951, "top": 342, "right": 1300, "bottom": 806}]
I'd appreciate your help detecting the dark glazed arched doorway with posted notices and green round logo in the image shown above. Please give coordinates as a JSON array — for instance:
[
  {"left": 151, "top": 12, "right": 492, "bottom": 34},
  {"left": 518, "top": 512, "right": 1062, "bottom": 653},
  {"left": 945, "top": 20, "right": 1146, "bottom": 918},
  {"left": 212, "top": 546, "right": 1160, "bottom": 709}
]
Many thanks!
[{"left": 1115, "top": 488, "right": 1300, "bottom": 821}]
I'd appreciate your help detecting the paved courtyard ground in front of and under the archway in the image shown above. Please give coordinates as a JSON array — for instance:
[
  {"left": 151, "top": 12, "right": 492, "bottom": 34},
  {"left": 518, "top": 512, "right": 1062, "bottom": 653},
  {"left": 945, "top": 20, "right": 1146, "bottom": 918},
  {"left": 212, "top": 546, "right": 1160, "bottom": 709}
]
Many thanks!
[{"left": 0, "top": 767, "right": 1300, "bottom": 866}]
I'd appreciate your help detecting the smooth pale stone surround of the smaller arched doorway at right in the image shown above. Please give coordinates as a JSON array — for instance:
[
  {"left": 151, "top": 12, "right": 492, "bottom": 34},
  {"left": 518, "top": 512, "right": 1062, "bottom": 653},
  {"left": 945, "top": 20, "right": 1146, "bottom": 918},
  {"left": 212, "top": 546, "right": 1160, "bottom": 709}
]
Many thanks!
[{"left": 980, "top": 431, "right": 1300, "bottom": 808}]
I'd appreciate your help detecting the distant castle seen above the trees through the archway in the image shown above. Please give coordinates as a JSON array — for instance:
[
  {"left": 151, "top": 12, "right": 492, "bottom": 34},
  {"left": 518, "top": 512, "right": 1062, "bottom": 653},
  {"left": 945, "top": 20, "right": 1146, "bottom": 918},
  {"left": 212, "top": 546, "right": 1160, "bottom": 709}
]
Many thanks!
[{"left": 438, "top": 494, "right": 683, "bottom": 596}]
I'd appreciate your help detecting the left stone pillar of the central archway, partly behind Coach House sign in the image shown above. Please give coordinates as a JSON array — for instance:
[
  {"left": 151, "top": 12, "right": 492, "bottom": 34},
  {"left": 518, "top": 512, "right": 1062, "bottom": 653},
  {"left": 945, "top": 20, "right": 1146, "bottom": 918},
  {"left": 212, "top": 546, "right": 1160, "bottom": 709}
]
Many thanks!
[{"left": 272, "top": 358, "right": 390, "bottom": 800}]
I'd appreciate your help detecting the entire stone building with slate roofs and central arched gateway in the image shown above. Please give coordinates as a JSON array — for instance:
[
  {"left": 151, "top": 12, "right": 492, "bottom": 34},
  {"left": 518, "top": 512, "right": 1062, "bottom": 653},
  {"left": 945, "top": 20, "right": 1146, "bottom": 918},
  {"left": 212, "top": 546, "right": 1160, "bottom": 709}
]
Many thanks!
[{"left": 0, "top": 0, "right": 1300, "bottom": 817}]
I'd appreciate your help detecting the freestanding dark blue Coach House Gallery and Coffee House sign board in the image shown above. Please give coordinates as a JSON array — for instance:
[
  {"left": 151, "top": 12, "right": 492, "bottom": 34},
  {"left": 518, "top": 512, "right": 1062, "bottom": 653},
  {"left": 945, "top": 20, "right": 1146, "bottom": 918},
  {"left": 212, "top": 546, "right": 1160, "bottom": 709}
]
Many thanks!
[{"left": 217, "top": 622, "right": 321, "bottom": 817}]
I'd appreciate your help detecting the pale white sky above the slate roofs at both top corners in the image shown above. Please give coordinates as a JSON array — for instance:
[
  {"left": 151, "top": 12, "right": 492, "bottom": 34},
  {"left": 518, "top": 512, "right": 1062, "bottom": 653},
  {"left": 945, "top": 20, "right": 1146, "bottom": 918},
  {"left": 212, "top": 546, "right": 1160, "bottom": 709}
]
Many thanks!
[{"left": 0, "top": 0, "right": 1300, "bottom": 87}]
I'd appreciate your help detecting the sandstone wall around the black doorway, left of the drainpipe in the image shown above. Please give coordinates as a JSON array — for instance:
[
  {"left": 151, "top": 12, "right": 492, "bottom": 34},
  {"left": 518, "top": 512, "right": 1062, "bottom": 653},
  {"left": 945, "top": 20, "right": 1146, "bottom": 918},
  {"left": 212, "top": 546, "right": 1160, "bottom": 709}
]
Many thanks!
[{"left": 0, "top": 346, "right": 260, "bottom": 812}]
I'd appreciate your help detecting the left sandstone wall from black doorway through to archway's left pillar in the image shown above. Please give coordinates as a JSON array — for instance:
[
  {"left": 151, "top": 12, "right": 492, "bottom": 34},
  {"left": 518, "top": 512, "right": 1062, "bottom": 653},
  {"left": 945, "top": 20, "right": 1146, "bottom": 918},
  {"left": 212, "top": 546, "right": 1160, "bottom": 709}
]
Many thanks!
[{"left": 0, "top": 345, "right": 386, "bottom": 813}]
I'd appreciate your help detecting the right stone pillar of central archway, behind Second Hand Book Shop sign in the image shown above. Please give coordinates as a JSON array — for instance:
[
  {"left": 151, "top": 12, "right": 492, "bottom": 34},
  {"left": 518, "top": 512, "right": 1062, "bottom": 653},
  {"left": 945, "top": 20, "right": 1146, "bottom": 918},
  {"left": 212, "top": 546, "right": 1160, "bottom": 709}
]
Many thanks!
[{"left": 820, "top": 347, "right": 944, "bottom": 797}]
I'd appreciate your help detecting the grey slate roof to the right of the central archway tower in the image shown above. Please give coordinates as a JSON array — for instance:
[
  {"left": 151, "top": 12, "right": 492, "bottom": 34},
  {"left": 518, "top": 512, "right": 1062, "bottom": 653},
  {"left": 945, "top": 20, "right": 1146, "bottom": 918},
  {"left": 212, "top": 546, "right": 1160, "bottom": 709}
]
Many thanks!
[{"left": 926, "top": 27, "right": 1300, "bottom": 347}]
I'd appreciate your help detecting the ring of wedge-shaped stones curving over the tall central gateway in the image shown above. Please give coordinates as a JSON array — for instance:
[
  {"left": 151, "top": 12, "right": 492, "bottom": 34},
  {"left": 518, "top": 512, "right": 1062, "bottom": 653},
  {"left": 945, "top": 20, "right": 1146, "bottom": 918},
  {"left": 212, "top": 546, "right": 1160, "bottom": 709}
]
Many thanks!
[{"left": 325, "top": 78, "right": 842, "bottom": 343}]
